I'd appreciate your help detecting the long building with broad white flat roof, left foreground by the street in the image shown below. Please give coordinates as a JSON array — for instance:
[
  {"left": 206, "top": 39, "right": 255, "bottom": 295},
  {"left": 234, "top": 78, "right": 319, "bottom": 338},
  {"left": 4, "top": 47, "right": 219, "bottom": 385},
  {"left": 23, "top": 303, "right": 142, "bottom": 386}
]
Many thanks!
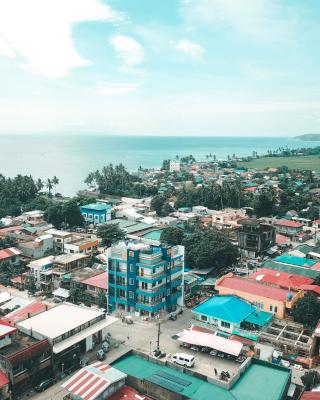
[{"left": 17, "top": 303, "right": 116, "bottom": 371}]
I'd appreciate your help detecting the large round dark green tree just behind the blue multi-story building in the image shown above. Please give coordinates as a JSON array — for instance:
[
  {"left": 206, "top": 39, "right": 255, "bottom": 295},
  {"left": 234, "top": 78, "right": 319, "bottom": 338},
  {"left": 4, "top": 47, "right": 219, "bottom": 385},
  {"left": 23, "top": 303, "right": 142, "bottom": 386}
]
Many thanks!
[{"left": 182, "top": 228, "right": 239, "bottom": 274}]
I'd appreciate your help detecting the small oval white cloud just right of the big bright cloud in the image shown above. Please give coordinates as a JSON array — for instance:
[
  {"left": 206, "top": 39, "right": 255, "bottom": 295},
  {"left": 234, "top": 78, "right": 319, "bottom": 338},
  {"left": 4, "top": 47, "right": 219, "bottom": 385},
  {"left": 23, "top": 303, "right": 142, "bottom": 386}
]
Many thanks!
[{"left": 110, "top": 35, "right": 144, "bottom": 68}]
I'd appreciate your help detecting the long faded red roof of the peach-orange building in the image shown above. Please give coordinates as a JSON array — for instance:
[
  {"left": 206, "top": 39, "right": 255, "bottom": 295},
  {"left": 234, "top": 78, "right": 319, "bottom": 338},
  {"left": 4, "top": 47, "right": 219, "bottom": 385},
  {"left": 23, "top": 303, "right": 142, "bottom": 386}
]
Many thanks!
[{"left": 216, "top": 276, "right": 289, "bottom": 301}]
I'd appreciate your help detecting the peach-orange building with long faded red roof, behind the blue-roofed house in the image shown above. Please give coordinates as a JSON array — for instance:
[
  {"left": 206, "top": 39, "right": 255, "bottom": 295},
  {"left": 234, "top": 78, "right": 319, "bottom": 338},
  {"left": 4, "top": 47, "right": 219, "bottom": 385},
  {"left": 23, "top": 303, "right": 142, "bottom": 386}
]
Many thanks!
[{"left": 215, "top": 273, "right": 303, "bottom": 319}]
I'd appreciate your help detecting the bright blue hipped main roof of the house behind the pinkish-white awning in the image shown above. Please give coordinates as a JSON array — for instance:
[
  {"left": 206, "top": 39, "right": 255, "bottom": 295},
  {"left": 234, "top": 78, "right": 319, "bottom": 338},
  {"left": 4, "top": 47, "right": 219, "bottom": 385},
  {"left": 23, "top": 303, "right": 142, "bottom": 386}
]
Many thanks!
[{"left": 192, "top": 295, "right": 256, "bottom": 323}]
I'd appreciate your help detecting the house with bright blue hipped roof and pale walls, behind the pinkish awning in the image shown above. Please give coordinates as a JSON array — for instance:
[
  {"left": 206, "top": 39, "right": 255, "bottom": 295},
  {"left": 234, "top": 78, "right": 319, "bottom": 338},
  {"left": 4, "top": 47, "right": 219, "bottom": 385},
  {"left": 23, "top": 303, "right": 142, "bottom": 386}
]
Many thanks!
[{"left": 192, "top": 295, "right": 272, "bottom": 340}]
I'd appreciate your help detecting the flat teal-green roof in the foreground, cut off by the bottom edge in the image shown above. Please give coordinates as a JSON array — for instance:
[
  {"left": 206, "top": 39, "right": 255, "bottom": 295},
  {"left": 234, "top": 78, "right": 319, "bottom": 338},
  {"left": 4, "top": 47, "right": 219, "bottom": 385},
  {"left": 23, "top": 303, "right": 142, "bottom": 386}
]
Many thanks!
[{"left": 112, "top": 354, "right": 291, "bottom": 400}]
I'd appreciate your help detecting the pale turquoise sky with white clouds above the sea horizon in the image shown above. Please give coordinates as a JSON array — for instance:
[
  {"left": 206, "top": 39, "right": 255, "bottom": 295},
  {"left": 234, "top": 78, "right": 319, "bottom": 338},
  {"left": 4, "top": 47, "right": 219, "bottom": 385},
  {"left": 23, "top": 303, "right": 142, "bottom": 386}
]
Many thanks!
[{"left": 0, "top": 0, "right": 320, "bottom": 136}]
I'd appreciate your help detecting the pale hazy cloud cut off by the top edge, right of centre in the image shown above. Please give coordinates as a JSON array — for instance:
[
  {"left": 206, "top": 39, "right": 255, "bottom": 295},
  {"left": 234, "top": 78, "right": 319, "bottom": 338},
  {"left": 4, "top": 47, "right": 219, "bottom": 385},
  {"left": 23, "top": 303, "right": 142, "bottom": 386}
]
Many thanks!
[{"left": 181, "top": 0, "right": 294, "bottom": 39}]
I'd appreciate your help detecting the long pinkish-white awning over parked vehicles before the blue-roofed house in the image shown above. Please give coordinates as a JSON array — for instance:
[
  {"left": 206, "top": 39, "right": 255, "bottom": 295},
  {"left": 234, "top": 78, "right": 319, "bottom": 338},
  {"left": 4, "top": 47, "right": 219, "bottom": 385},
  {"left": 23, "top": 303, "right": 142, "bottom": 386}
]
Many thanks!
[{"left": 178, "top": 330, "right": 243, "bottom": 357}]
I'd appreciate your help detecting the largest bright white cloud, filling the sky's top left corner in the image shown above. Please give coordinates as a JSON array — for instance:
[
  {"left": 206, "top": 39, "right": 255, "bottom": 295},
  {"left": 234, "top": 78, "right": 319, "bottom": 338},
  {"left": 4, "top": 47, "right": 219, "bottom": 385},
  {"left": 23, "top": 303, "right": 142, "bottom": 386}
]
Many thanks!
[{"left": 0, "top": 0, "right": 123, "bottom": 78}]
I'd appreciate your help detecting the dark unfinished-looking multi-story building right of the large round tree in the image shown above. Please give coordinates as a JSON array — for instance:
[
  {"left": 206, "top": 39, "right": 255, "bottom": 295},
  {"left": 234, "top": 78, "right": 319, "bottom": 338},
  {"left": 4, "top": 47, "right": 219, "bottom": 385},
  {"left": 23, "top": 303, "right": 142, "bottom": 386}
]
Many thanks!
[{"left": 237, "top": 218, "right": 276, "bottom": 258}]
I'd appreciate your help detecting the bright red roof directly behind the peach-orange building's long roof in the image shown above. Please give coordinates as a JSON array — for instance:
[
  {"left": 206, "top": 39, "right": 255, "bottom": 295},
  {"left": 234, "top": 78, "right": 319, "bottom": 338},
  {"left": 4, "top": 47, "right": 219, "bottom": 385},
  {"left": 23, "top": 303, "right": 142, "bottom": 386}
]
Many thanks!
[{"left": 249, "top": 268, "right": 314, "bottom": 289}]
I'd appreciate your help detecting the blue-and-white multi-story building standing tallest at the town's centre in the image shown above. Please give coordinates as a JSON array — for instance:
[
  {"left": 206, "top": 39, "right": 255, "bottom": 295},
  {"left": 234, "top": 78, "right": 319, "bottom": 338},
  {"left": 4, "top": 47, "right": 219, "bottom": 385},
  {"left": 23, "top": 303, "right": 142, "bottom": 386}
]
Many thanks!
[{"left": 108, "top": 242, "right": 184, "bottom": 317}]
